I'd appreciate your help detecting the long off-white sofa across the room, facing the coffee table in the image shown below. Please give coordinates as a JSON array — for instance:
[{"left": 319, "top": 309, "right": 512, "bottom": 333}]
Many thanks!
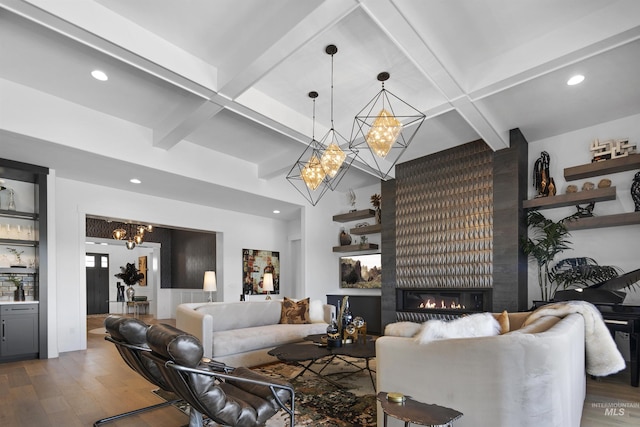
[{"left": 176, "top": 300, "right": 335, "bottom": 367}]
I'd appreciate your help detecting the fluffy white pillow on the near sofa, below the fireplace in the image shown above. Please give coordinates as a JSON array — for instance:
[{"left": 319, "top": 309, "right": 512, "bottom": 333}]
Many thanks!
[{"left": 415, "top": 313, "right": 500, "bottom": 344}]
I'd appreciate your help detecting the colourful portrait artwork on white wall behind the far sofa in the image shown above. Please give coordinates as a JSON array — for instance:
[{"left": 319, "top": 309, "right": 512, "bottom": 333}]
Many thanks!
[{"left": 242, "top": 249, "right": 280, "bottom": 295}]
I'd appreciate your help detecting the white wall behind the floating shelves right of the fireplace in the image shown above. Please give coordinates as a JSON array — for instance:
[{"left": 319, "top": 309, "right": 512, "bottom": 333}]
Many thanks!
[{"left": 525, "top": 115, "right": 640, "bottom": 304}]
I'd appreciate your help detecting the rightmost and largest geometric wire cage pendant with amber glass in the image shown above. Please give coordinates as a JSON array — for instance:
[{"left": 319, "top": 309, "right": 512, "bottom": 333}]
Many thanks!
[{"left": 349, "top": 72, "right": 426, "bottom": 180}]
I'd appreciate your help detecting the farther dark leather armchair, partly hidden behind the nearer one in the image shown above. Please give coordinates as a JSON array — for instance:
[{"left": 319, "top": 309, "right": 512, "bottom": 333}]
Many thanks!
[{"left": 93, "top": 316, "right": 198, "bottom": 427}]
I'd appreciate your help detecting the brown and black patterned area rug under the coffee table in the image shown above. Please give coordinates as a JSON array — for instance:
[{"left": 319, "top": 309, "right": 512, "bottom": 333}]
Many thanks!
[{"left": 154, "top": 358, "right": 376, "bottom": 427}]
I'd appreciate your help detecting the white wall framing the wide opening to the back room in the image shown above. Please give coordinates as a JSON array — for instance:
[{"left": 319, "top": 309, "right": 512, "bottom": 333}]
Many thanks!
[{"left": 49, "top": 178, "right": 296, "bottom": 357}]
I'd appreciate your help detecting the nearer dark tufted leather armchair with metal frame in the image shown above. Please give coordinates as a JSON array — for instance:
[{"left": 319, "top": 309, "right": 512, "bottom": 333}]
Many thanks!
[{"left": 143, "top": 324, "right": 295, "bottom": 427}]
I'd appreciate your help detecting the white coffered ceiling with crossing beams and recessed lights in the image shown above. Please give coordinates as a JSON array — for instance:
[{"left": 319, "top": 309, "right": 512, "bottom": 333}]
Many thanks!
[{"left": 0, "top": 0, "right": 640, "bottom": 221}]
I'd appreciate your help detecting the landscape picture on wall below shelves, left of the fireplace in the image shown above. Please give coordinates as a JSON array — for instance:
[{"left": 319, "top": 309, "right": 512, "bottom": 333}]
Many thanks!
[{"left": 340, "top": 254, "right": 382, "bottom": 289}]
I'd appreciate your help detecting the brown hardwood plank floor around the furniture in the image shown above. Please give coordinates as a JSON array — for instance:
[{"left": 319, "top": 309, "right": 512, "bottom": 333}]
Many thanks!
[{"left": 0, "top": 316, "right": 640, "bottom": 427}]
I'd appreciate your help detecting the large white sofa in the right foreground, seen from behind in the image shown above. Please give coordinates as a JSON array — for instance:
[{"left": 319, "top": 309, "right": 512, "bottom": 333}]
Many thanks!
[{"left": 376, "top": 313, "right": 586, "bottom": 427}]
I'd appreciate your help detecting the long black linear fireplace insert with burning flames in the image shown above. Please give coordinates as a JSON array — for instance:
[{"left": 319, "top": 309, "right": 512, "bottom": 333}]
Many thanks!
[{"left": 396, "top": 288, "right": 492, "bottom": 321}]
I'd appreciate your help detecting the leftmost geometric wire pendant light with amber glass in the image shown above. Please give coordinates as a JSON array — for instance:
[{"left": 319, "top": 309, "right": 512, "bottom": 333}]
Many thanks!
[{"left": 287, "top": 91, "right": 329, "bottom": 206}]
